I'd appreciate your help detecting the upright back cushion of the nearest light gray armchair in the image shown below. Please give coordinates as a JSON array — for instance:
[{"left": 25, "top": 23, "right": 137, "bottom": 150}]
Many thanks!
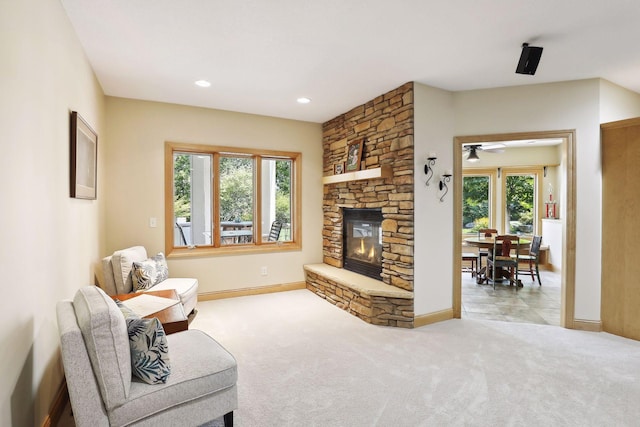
[{"left": 73, "top": 286, "right": 131, "bottom": 410}]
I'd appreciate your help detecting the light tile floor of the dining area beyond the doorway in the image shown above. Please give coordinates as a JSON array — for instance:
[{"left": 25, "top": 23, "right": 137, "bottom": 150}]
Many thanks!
[{"left": 462, "top": 270, "right": 561, "bottom": 326}]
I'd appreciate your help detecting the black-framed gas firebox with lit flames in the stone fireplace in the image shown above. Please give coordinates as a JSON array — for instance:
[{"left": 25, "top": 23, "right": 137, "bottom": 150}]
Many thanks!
[{"left": 342, "top": 209, "right": 382, "bottom": 280}]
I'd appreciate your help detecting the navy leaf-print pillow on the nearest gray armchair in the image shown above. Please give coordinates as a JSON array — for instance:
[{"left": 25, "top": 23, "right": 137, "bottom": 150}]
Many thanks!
[{"left": 127, "top": 317, "right": 171, "bottom": 384}]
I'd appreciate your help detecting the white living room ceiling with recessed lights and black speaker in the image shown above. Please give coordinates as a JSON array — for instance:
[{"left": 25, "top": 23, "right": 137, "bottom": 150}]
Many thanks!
[{"left": 60, "top": 0, "right": 640, "bottom": 123}]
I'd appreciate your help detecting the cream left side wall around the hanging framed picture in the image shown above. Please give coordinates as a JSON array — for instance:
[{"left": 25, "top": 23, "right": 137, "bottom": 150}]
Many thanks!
[{"left": 0, "top": 0, "right": 106, "bottom": 426}]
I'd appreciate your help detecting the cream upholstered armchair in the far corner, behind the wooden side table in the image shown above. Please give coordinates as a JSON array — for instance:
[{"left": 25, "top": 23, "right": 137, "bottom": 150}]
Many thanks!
[{"left": 98, "top": 246, "right": 198, "bottom": 314}]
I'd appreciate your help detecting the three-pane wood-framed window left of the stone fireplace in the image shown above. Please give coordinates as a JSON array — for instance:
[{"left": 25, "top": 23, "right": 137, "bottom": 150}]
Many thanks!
[{"left": 165, "top": 142, "right": 301, "bottom": 256}]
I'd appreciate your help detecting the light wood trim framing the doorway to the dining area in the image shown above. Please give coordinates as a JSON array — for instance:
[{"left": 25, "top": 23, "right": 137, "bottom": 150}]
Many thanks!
[{"left": 453, "top": 129, "right": 576, "bottom": 329}]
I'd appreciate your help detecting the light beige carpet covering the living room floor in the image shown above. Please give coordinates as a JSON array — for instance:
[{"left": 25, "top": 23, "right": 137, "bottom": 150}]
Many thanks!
[{"left": 191, "top": 290, "right": 640, "bottom": 427}]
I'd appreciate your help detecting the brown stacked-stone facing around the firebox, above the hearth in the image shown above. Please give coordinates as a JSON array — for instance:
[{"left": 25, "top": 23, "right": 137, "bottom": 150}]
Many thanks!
[{"left": 308, "top": 82, "right": 414, "bottom": 328}]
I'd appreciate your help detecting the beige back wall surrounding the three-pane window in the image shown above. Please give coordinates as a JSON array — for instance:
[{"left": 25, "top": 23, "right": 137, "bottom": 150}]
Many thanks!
[{"left": 103, "top": 97, "right": 322, "bottom": 293}]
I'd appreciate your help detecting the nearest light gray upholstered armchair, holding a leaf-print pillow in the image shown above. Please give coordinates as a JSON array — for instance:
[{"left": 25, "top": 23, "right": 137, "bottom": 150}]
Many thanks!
[{"left": 56, "top": 286, "right": 238, "bottom": 427}]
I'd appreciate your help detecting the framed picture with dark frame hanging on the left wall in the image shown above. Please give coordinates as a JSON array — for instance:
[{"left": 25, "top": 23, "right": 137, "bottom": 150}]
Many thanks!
[{"left": 69, "top": 111, "right": 98, "bottom": 200}]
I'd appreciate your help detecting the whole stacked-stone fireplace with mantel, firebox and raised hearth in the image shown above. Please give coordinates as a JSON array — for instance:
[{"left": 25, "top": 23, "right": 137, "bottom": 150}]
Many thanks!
[{"left": 305, "top": 83, "right": 414, "bottom": 328}]
